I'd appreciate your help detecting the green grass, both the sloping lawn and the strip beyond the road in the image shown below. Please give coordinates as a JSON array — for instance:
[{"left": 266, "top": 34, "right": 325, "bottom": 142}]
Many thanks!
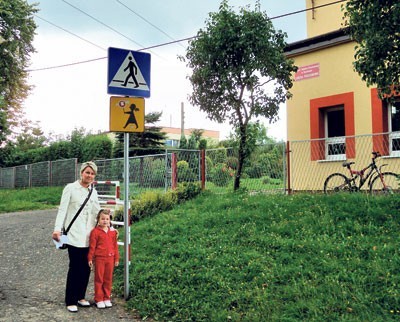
[{"left": 0, "top": 188, "right": 400, "bottom": 322}]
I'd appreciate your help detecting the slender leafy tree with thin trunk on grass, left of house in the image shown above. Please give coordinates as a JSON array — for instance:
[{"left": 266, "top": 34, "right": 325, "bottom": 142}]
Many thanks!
[{"left": 186, "top": 0, "right": 297, "bottom": 190}]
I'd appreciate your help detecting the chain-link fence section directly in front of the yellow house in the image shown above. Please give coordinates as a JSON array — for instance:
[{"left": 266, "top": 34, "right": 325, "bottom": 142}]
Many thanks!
[{"left": 288, "top": 133, "right": 400, "bottom": 192}]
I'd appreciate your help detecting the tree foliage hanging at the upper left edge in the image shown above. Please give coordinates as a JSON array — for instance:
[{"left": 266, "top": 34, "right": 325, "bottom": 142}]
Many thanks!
[{"left": 0, "top": 0, "right": 38, "bottom": 146}]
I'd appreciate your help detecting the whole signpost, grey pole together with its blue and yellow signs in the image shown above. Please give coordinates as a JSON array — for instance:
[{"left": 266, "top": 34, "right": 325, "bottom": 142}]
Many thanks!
[{"left": 107, "top": 47, "right": 151, "bottom": 300}]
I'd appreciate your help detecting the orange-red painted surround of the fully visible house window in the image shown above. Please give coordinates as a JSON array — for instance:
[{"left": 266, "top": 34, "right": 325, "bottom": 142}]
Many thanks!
[{"left": 310, "top": 92, "right": 356, "bottom": 161}]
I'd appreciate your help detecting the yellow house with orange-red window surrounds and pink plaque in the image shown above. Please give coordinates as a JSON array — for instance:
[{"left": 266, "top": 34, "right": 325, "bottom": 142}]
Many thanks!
[{"left": 285, "top": 0, "right": 400, "bottom": 190}]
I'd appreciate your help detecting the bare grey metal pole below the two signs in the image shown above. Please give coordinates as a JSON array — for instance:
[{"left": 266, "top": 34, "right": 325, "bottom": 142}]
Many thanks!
[{"left": 124, "top": 132, "right": 131, "bottom": 300}]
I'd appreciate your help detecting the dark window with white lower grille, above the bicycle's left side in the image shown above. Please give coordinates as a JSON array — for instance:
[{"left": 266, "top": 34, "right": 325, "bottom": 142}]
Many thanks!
[{"left": 325, "top": 106, "right": 346, "bottom": 160}]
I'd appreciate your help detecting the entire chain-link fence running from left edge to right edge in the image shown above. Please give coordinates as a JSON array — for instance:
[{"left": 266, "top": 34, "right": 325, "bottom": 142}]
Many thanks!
[{"left": 0, "top": 133, "right": 400, "bottom": 194}]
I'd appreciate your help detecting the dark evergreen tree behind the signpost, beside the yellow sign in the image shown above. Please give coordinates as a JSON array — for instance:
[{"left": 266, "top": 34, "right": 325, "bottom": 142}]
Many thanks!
[{"left": 114, "top": 112, "right": 166, "bottom": 157}]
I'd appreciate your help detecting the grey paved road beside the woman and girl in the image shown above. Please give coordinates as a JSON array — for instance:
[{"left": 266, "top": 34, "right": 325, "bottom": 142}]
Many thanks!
[{"left": 0, "top": 210, "right": 140, "bottom": 322}]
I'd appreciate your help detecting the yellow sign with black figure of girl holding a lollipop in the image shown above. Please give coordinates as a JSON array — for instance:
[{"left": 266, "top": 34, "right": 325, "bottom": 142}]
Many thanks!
[{"left": 110, "top": 96, "right": 144, "bottom": 132}]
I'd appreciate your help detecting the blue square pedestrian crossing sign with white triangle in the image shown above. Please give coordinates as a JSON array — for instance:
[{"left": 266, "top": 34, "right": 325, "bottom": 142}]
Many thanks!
[{"left": 107, "top": 47, "right": 151, "bottom": 97}]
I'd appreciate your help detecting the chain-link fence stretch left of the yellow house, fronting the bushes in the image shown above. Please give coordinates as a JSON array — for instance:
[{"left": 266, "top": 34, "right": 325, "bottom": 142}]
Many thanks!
[{"left": 0, "top": 147, "right": 286, "bottom": 195}]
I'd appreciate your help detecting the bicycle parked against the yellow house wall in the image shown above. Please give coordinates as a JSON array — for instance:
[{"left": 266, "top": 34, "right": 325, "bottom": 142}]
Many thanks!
[{"left": 324, "top": 152, "right": 400, "bottom": 194}]
